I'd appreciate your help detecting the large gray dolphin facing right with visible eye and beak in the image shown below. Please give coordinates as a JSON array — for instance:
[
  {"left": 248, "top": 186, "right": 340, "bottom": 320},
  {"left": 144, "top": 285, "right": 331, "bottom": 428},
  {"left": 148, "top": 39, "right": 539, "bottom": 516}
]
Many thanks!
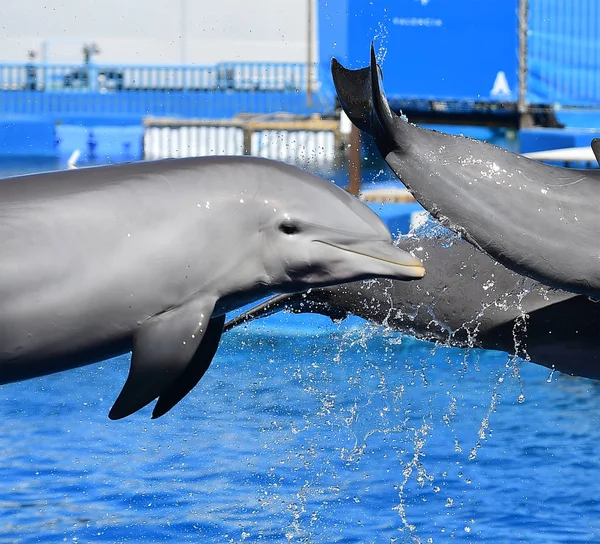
[{"left": 0, "top": 157, "right": 424, "bottom": 419}]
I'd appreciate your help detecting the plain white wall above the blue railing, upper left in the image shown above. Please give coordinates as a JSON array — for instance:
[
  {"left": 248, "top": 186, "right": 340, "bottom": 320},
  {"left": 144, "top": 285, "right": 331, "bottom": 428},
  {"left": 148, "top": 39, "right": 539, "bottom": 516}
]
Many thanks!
[{"left": 0, "top": 0, "right": 317, "bottom": 64}]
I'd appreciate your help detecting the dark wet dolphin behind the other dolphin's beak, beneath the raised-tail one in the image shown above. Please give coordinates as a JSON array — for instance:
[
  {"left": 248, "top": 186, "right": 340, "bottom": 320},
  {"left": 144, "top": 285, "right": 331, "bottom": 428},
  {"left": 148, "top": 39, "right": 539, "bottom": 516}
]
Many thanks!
[{"left": 225, "top": 226, "right": 600, "bottom": 380}]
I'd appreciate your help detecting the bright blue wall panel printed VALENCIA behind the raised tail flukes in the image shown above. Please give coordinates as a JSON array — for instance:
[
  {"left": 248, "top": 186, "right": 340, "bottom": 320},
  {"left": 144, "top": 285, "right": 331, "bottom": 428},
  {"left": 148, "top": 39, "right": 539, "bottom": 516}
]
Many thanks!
[{"left": 319, "top": 0, "right": 518, "bottom": 101}]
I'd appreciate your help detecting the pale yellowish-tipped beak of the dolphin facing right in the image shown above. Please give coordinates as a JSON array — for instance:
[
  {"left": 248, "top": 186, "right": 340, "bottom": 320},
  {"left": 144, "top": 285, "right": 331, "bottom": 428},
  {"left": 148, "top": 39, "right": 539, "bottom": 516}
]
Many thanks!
[{"left": 315, "top": 240, "right": 425, "bottom": 280}]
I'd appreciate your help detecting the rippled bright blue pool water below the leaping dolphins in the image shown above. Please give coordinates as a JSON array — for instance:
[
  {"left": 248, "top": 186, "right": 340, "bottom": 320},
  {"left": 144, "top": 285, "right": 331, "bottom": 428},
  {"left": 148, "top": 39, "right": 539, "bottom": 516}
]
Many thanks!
[{"left": 0, "top": 158, "right": 600, "bottom": 544}]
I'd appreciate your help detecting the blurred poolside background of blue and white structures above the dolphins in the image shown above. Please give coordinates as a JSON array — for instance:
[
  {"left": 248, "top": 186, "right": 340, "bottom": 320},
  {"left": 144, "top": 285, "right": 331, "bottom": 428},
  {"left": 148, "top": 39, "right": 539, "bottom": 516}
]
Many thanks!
[{"left": 0, "top": 0, "right": 600, "bottom": 176}]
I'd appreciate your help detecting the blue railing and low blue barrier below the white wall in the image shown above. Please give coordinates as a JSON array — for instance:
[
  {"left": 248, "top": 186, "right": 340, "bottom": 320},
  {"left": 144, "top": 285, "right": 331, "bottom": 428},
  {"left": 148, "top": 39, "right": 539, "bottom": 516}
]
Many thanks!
[{"left": 0, "top": 89, "right": 333, "bottom": 157}]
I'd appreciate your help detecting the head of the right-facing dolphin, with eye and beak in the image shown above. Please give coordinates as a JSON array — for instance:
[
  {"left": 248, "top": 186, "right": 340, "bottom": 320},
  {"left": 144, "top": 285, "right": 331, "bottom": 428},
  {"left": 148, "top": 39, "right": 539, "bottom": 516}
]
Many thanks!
[{"left": 256, "top": 159, "right": 425, "bottom": 292}]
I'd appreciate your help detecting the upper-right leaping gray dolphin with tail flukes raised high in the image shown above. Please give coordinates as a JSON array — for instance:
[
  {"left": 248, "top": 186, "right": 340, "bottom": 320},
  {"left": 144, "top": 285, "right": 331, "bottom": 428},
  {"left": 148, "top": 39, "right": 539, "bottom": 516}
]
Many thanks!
[{"left": 332, "top": 43, "right": 600, "bottom": 296}]
